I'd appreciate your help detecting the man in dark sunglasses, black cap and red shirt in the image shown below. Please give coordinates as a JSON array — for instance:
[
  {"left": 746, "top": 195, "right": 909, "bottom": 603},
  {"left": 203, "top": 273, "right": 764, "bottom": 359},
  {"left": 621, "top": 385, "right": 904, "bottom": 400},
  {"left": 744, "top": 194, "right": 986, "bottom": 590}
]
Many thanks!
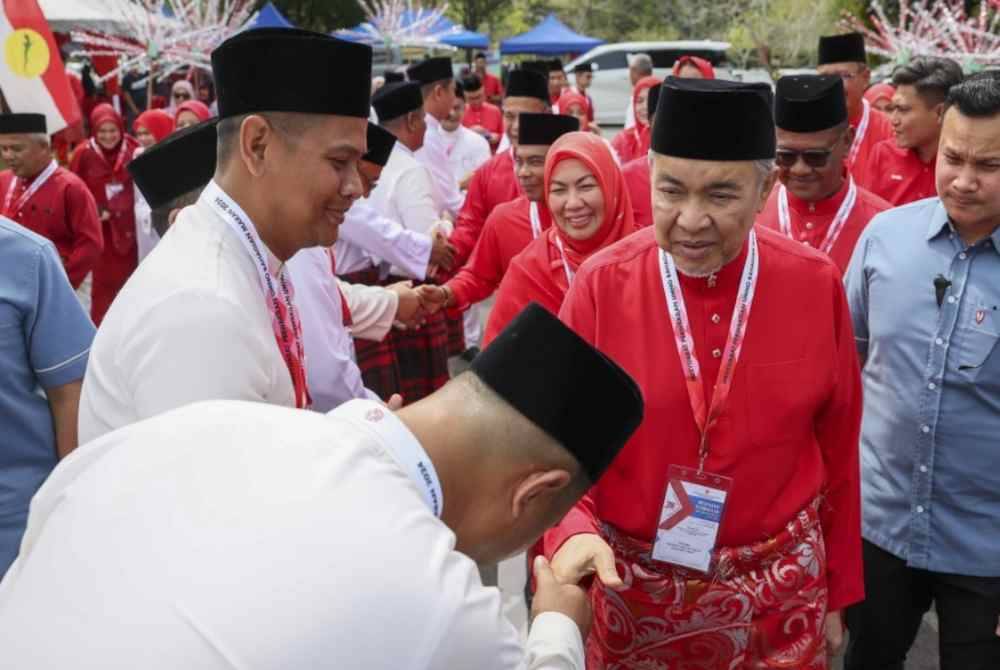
[{"left": 757, "top": 75, "right": 891, "bottom": 273}]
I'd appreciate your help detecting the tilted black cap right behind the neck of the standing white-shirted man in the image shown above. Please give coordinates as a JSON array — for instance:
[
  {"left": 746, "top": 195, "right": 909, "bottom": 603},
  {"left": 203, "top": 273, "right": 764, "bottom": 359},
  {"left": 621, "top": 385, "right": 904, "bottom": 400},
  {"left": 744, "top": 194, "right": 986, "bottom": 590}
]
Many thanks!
[{"left": 128, "top": 119, "right": 217, "bottom": 209}]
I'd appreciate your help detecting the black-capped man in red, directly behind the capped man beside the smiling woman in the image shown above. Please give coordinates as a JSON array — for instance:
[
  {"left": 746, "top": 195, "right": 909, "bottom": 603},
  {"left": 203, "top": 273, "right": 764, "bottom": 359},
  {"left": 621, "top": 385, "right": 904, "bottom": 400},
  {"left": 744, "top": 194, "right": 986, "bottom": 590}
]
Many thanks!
[{"left": 448, "top": 70, "right": 549, "bottom": 276}]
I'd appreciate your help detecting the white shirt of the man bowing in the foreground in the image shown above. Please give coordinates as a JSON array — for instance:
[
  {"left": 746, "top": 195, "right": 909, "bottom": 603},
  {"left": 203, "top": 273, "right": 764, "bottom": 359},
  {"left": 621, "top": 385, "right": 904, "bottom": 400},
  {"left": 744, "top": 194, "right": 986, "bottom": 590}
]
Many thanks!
[{"left": 0, "top": 400, "right": 583, "bottom": 670}]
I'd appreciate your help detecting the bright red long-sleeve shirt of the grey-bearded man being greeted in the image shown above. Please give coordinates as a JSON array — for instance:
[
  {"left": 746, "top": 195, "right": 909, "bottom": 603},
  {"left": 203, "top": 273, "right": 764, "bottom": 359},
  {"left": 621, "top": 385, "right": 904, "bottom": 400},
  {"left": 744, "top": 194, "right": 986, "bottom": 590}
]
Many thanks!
[{"left": 544, "top": 228, "right": 864, "bottom": 610}]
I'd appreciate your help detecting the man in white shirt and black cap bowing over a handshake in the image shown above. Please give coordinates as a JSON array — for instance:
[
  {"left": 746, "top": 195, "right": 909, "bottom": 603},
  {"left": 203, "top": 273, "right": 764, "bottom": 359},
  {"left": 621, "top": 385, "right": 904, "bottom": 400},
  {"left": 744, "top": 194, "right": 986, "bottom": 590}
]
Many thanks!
[{"left": 0, "top": 306, "right": 643, "bottom": 670}]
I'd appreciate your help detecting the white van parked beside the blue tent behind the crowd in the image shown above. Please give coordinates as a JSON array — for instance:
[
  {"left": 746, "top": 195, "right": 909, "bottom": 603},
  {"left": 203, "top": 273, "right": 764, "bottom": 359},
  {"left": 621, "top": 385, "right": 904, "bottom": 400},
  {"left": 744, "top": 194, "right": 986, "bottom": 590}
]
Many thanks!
[{"left": 566, "top": 40, "right": 743, "bottom": 126}]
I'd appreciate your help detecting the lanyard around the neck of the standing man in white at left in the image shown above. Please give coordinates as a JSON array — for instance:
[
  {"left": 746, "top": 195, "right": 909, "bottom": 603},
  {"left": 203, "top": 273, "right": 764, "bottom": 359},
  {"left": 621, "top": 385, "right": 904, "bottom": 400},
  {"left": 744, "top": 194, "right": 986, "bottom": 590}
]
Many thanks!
[{"left": 205, "top": 181, "right": 309, "bottom": 409}]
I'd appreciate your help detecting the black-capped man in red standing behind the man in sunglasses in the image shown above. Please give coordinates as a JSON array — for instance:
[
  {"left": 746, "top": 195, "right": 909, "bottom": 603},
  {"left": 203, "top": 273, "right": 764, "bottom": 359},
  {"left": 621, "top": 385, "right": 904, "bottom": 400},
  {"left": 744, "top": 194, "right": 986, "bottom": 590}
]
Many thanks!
[{"left": 816, "top": 33, "right": 892, "bottom": 190}]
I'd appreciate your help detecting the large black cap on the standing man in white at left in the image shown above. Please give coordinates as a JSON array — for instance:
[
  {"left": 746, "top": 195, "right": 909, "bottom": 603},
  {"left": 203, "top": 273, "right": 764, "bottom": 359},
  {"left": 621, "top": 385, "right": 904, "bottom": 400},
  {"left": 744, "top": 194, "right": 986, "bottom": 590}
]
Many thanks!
[{"left": 212, "top": 28, "right": 372, "bottom": 119}]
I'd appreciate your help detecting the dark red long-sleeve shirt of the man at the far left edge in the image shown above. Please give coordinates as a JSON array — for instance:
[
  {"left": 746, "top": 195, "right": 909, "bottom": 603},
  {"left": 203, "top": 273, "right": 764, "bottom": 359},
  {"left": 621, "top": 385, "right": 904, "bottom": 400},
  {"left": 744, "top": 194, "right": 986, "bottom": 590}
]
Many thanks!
[{"left": 0, "top": 168, "right": 104, "bottom": 288}]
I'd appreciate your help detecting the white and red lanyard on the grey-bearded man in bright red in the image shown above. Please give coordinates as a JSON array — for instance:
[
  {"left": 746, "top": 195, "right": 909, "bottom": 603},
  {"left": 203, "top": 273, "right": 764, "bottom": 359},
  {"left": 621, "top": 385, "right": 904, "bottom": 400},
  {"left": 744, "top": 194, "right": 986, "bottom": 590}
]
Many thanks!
[{"left": 660, "top": 230, "right": 760, "bottom": 473}]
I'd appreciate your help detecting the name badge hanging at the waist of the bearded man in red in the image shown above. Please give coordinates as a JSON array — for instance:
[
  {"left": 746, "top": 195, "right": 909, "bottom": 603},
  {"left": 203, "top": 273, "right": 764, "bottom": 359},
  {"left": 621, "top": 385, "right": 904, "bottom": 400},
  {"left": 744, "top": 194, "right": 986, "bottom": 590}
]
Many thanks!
[{"left": 652, "top": 465, "right": 733, "bottom": 572}]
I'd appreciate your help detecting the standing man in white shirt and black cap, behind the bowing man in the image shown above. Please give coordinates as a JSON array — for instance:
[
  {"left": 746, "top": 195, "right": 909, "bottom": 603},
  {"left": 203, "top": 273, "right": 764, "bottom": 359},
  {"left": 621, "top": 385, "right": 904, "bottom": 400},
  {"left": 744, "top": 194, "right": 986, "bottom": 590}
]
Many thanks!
[{"left": 80, "top": 29, "right": 371, "bottom": 440}]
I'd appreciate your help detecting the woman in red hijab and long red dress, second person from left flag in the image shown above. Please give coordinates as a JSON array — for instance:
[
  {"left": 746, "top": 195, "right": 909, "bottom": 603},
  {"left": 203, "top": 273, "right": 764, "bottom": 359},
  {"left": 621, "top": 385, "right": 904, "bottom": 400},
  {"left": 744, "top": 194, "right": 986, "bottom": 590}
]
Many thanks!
[{"left": 69, "top": 103, "right": 139, "bottom": 325}]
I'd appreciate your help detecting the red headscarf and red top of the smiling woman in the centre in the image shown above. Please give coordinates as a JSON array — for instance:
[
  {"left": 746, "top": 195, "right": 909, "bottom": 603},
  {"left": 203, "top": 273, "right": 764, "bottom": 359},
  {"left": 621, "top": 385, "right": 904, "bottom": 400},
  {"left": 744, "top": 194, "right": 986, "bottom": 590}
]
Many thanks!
[{"left": 483, "top": 132, "right": 635, "bottom": 346}]
